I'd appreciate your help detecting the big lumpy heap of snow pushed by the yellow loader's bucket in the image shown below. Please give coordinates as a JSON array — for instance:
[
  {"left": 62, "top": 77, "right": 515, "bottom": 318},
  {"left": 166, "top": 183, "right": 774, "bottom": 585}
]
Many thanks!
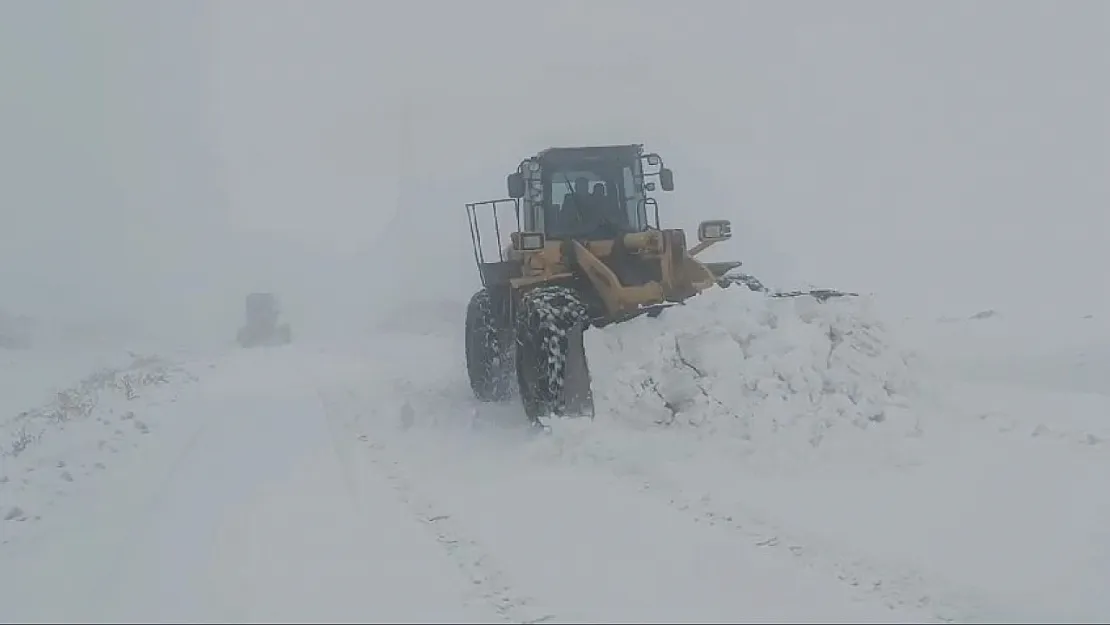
[{"left": 586, "top": 288, "right": 920, "bottom": 459}]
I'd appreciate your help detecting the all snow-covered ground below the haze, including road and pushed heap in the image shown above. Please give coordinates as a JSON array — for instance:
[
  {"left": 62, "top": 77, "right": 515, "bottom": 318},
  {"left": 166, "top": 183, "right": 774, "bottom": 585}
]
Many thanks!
[{"left": 0, "top": 289, "right": 1110, "bottom": 622}]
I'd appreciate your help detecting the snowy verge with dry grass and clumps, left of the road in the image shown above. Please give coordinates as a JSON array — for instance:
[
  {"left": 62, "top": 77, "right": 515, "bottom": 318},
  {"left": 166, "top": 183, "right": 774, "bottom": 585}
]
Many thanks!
[{"left": 0, "top": 351, "right": 203, "bottom": 537}]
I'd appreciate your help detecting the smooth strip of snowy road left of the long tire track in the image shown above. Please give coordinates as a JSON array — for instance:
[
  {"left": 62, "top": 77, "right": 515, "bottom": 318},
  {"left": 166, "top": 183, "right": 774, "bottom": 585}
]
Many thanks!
[{"left": 0, "top": 352, "right": 497, "bottom": 622}]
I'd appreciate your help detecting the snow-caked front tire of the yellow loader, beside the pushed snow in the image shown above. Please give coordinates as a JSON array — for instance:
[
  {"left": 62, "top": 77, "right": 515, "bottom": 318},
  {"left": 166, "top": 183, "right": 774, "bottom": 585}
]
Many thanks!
[{"left": 516, "top": 286, "right": 593, "bottom": 423}]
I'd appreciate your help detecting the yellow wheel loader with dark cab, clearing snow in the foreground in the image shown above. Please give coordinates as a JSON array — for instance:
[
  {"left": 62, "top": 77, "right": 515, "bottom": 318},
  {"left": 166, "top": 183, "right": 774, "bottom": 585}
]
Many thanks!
[{"left": 465, "top": 144, "right": 850, "bottom": 423}]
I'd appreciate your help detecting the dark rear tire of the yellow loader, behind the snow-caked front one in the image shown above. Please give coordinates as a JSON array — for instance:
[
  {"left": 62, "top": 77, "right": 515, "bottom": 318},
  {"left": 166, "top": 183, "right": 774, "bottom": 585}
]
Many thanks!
[{"left": 465, "top": 289, "right": 513, "bottom": 402}]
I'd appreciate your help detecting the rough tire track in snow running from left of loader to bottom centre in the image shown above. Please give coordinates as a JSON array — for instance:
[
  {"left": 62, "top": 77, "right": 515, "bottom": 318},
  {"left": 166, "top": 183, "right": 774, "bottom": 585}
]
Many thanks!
[{"left": 319, "top": 390, "right": 556, "bottom": 623}]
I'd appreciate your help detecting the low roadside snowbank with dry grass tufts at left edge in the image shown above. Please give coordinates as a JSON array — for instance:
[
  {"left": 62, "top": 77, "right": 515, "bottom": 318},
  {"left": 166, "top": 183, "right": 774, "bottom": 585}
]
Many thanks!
[{"left": 0, "top": 356, "right": 194, "bottom": 523}]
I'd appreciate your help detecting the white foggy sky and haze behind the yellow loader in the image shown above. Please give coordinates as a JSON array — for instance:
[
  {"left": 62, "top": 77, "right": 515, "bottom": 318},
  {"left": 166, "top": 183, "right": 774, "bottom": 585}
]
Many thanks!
[{"left": 0, "top": 0, "right": 1110, "bottom": 340}]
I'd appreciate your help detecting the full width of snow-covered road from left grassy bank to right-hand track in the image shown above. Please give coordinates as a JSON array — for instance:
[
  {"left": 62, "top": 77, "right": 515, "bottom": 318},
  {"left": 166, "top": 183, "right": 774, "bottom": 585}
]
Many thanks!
[{"left": 0, "top": 350, "right": 919, "bottom": 622}]
